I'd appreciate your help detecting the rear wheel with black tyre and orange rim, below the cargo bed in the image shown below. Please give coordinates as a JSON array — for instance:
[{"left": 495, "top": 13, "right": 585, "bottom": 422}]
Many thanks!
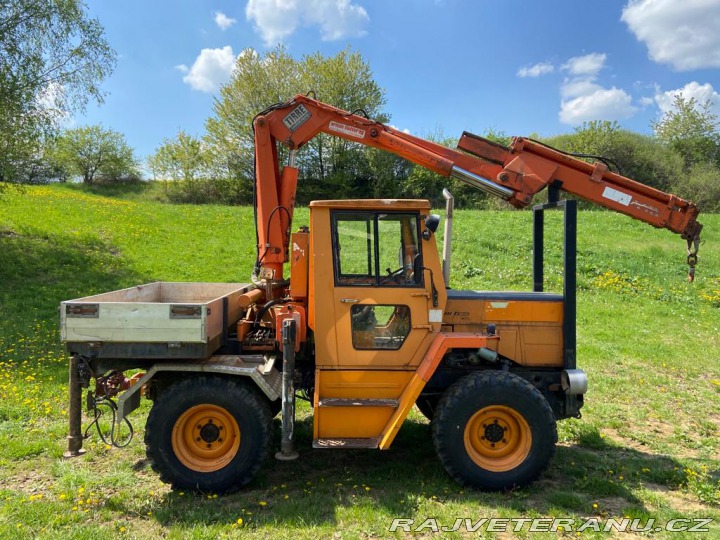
[{"left": 145, "top": 376, "right": 272, "bottom": 493}]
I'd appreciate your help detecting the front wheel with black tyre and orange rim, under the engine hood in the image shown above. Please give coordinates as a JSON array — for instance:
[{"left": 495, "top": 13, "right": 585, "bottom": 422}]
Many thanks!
[{"left": 432, "top": 371, "right": 557, "bottom": 491}]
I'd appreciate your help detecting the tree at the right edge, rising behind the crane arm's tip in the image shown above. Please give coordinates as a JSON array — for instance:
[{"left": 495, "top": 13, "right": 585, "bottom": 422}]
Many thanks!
[{"left": 652, "top": 94, "right": 720, "bottom": 167}]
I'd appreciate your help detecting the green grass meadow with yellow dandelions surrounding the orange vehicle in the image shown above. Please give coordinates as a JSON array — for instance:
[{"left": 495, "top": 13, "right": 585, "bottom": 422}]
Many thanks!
[{"left": 0, "top": 186, "right": 720, "bottom": 539}]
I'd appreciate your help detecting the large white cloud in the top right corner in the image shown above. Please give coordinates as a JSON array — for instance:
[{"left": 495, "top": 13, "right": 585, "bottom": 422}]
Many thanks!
[{"left": 621, "top": 0, "right": 720, "bottom": 71}]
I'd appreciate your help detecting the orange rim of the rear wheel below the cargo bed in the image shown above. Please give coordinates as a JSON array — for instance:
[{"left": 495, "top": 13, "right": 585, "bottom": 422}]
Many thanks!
[{"left": 172, "top": 404, "right": 240, "bottom": 472}]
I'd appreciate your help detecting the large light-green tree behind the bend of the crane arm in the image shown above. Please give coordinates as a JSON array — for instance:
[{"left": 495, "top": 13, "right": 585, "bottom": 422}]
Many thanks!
[{"left": 206, "top": 47, "right": 388, "bottom": 202}]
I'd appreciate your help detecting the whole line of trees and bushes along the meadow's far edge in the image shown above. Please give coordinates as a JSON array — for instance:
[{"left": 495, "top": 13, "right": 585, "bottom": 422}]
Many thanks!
[{"left": 0, "top": 0, "right": 720, "bottom": 211}]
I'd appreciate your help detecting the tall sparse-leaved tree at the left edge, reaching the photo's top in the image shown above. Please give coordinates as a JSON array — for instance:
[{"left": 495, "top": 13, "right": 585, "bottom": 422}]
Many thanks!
[{"left": 0, "top": 0, "right": 115, "bottom": 182}]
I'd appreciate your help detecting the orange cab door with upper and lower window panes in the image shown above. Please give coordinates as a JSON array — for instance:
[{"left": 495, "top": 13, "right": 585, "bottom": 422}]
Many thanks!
[{"left": 331, "top": 210, "right": 432, "bottom": 369}]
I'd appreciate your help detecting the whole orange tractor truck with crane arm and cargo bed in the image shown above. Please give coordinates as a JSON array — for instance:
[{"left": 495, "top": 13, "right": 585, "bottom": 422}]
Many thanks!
[{"left": 61, "top": 95, "right": 702, "bottom": 491}]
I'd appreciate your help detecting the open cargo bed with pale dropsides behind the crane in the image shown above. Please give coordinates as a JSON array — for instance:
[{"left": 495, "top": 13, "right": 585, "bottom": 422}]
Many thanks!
[{"left": 60, "top": 281, "right": 253, "bottom": 360}]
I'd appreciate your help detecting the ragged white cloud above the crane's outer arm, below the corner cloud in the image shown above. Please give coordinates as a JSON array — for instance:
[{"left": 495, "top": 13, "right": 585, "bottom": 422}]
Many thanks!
[{"left": 560, "top": 53, "right": 637, "bottom": 125}]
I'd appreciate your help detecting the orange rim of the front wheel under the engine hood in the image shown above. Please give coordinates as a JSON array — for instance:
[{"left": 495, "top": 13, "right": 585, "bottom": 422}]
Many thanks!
[{"left": 463, "top": 405, "right": 532, "bottom": 472}]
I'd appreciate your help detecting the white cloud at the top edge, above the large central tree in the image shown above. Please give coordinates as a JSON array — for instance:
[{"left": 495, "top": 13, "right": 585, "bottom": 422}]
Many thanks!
[{"left": 245, "top": 0, "right": 370, "bottom": 45}]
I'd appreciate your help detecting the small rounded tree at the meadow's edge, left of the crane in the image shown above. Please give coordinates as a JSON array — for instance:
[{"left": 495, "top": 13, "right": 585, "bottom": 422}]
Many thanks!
[{"left": 52, "top": 125, "right": 140, "bottom": 185}]
